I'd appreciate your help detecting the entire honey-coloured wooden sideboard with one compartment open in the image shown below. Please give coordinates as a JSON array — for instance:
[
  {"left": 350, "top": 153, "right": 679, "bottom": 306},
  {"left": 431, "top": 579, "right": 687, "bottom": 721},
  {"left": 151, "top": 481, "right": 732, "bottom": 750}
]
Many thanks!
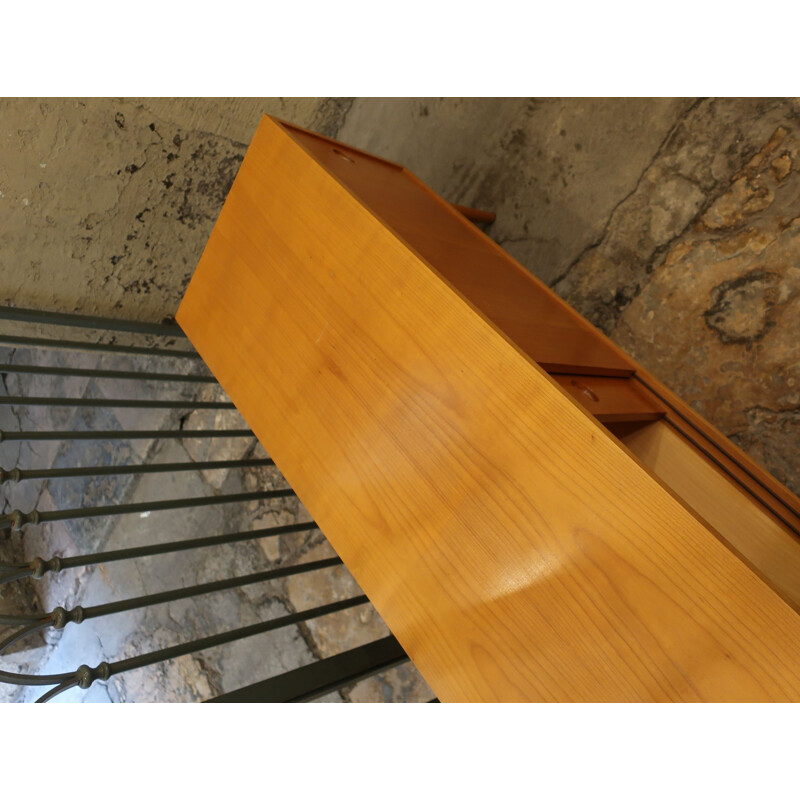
[{"left": 177, "top": 117, "right": 800, "bottom": 701}]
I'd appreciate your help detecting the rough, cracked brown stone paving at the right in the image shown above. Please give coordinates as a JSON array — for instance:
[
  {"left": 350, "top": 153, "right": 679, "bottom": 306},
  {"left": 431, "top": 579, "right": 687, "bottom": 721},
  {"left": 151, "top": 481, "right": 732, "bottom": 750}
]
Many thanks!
[{"left": 556, "top": 100, "right": 800, "bottom": 493}]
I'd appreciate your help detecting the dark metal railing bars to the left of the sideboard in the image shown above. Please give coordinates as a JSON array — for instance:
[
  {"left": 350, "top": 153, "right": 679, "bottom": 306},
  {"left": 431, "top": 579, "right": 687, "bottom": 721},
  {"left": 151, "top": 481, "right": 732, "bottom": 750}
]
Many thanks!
[{"left": 0, "top": 308, "right": 422, "bottom": 702}]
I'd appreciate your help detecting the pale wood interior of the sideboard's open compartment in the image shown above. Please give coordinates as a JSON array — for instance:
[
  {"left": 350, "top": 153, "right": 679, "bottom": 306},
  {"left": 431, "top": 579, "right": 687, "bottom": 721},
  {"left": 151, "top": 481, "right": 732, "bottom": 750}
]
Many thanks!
[{"left": 621, "top": 422, "right": 800, "bottom": 608}]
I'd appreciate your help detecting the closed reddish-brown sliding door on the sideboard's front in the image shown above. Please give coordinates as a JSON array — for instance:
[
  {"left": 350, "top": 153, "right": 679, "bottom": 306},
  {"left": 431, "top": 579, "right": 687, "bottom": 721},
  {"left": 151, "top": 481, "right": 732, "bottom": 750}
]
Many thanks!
[{"left": 278, "top": 120, "right": 632, "bottom": 375}]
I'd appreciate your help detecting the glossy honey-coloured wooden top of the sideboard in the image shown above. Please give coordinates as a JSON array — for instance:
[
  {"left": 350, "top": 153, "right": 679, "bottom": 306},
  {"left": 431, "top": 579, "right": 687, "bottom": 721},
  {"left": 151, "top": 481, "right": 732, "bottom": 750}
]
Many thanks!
[{"left": 178, "top": 118, "right": 800, "bottom": 701}]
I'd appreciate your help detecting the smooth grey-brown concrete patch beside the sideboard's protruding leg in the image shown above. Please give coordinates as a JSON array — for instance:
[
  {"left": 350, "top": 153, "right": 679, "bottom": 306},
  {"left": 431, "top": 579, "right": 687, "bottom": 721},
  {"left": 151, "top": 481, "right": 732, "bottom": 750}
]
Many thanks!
[{"left": 338, "top": 98, "right": 691, "bottom": 282}]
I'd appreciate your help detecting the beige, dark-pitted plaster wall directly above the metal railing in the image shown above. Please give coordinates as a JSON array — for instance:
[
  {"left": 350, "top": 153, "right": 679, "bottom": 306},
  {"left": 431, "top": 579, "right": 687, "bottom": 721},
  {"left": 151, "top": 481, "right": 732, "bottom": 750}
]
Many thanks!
[{"left": 0, "top": 100, "right": 332, "bottom": 319}]
